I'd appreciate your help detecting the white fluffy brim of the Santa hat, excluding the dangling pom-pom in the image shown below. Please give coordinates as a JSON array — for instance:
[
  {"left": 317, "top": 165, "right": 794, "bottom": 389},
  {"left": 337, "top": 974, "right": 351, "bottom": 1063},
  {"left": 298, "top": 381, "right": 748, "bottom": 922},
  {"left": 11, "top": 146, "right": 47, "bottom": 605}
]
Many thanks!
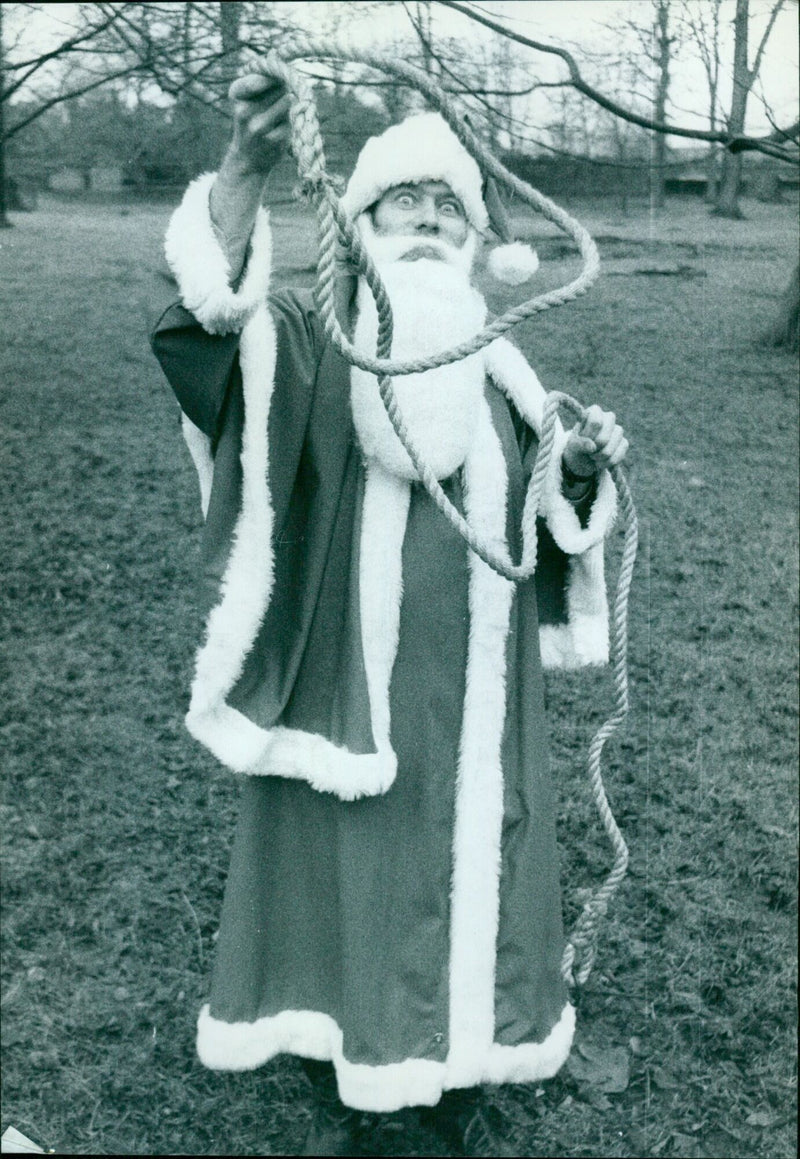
[{"left": 342, "top": 112, "right": 489, "bottom": 233}]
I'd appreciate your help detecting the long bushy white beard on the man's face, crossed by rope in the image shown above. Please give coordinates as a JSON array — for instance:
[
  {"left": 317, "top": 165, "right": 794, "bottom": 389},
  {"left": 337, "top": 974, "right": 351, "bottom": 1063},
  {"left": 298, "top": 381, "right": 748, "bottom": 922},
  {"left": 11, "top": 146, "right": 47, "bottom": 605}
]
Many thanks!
[{"left": 350, "top": 221, "right": 486, "bottom": 480}]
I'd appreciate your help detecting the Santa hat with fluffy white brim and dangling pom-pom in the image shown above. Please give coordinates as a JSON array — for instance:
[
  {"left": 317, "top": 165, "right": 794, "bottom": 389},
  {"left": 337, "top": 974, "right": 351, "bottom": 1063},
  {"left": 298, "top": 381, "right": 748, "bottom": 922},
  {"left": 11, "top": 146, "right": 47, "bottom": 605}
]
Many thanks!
[{"left": 342, "top": 112, "right": 539, "bottom": 285}]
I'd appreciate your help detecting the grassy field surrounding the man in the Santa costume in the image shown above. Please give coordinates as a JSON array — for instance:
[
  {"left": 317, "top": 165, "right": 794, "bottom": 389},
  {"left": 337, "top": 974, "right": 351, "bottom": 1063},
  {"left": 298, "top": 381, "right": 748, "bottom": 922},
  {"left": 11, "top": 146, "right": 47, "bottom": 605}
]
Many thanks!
[{"left": 0, "top": 192, "right": 798, "bottom": 1159}]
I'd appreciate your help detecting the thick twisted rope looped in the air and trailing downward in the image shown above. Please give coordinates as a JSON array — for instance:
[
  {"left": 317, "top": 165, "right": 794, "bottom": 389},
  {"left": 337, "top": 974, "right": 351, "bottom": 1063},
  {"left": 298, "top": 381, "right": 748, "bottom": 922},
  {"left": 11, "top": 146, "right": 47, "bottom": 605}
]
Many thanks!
[{"left": 259, "top": 37, "right": 638, "bottom": 985}]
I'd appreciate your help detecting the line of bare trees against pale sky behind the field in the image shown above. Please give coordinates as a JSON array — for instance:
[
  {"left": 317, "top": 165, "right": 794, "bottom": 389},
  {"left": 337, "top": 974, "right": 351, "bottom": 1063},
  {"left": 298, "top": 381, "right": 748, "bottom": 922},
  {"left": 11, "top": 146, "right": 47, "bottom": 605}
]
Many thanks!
[{"left": 0, "top": 0, "right": 799, "bottom": 343}]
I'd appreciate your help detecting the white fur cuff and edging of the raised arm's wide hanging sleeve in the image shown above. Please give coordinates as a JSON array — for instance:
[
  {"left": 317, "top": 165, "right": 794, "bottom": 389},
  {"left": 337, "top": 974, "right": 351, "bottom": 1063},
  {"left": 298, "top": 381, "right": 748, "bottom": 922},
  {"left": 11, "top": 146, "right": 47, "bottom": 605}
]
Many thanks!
[{"left": 166, "top": 185, "right": 397, "bottom": 801}]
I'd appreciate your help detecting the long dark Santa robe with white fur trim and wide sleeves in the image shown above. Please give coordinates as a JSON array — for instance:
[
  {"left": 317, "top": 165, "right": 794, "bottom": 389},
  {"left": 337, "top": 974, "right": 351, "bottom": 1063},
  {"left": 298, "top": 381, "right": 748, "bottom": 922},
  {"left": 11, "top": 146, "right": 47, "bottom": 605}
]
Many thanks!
[{"left": 154, "top": 175, "right": 616, "bottom": 1110}]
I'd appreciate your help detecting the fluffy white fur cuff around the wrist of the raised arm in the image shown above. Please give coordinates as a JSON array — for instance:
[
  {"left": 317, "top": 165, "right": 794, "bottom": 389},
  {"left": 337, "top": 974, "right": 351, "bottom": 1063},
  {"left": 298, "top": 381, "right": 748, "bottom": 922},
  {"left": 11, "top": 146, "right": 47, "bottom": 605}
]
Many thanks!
[{"left": 165, "top": 173, "right": 272, "bottom": 334}]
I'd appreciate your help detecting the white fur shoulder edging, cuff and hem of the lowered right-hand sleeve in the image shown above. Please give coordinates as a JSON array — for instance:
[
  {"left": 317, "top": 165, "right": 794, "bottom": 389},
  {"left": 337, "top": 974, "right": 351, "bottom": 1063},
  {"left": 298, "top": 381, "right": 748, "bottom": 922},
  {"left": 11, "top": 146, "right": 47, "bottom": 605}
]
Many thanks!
[{"left": 486, "top": 338, "right": 617, "bottom": 669}]
